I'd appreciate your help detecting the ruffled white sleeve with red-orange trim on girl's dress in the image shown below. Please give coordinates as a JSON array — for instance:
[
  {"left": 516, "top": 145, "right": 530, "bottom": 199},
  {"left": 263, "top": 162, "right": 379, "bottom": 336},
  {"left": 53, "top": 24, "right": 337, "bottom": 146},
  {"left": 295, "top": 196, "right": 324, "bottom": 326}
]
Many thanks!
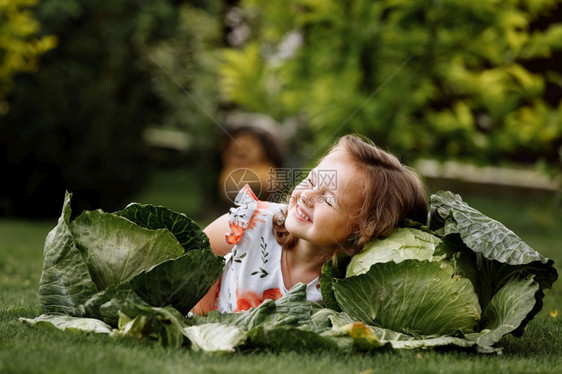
[{"left": 225, "top": 185, "right": 258, "bottom": 244}]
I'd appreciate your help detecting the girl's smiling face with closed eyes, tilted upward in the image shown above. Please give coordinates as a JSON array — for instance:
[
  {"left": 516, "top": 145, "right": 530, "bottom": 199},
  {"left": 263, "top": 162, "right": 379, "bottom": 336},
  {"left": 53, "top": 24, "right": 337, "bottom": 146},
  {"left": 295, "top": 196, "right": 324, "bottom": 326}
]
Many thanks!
[{"left": 285, "top": 149, "right": 363, "bottom": 248}]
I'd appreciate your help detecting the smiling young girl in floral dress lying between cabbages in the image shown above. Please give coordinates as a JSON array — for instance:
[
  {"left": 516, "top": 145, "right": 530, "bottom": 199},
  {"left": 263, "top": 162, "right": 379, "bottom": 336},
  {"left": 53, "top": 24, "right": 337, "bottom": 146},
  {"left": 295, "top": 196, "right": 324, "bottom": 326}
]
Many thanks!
[{"left": 193, "top": 135, "right": 427, "bottom": 314}]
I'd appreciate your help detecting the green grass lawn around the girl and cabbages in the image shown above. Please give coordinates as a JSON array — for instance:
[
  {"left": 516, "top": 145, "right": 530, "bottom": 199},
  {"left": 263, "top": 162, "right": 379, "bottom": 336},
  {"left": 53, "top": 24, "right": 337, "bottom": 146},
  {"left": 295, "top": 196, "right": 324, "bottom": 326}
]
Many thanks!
[{"left": 0, "top": 173, "right": 562, "bottom": 374}]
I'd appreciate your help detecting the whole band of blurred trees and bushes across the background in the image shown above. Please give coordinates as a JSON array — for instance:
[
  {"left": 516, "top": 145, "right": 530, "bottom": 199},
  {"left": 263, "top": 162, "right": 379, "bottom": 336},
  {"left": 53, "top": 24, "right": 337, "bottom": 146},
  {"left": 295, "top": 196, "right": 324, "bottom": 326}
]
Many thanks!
[{"left": 0, "top": 0, "right": 562, "bottom": 221}]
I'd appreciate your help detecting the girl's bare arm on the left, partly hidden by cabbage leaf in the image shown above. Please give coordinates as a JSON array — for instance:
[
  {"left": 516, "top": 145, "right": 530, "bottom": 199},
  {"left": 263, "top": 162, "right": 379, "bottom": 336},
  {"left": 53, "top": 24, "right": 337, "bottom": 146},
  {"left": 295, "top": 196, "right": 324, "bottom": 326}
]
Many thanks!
[{"left": 192, "top": 213, "right": 234, "bottom": 315}]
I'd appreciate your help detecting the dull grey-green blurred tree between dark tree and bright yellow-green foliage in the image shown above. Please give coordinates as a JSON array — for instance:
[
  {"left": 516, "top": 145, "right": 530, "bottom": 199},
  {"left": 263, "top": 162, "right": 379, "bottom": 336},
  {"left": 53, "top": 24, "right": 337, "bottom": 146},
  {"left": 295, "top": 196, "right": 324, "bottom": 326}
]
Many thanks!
[{"left": 138, "top": 1, "right": 226, "bottom": 191}]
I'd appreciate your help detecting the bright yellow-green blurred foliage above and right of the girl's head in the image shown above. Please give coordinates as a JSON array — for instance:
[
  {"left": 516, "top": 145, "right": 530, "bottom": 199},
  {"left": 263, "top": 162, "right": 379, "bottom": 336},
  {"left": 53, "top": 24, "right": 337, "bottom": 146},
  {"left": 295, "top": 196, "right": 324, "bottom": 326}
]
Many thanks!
[{"left": 220, "top": 0, "right": 562, "bottom": 172}]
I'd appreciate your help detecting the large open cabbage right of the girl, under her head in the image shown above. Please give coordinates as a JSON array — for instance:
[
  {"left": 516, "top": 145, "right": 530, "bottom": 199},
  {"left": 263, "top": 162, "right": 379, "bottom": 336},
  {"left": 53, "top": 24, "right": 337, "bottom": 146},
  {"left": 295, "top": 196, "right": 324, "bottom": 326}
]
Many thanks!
[{"left": 323, "top": 191, "right": 558, "bottom": 351}]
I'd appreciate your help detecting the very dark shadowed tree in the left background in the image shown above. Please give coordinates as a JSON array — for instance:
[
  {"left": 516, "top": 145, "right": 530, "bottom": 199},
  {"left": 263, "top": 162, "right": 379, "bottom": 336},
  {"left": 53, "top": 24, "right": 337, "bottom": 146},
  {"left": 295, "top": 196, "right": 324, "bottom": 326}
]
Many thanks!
[{"left": 0, "top": 0, "right": 222, "bottom": 216}]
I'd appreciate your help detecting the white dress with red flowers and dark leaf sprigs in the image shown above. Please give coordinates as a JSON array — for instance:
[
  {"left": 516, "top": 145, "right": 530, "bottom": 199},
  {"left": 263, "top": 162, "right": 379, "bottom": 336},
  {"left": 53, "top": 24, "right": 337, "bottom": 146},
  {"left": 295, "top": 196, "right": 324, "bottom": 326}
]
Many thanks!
[{"left": 215, "top": 185, "right": 322, "bottom": 313}]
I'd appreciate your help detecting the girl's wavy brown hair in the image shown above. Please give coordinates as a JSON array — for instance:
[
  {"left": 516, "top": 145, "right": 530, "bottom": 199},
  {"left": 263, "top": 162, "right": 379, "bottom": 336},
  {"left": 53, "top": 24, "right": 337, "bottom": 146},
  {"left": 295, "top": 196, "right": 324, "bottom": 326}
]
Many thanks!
[{"left": 273, "top": 135, "right": 427, "bottom": 255}]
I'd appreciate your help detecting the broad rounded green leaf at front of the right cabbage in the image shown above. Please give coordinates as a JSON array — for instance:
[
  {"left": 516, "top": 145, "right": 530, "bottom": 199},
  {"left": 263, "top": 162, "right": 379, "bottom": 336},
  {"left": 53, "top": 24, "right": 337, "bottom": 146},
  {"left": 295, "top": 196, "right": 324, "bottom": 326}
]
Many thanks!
[{"left": 333, "top": 260, "right": 481, "bottom": 335}]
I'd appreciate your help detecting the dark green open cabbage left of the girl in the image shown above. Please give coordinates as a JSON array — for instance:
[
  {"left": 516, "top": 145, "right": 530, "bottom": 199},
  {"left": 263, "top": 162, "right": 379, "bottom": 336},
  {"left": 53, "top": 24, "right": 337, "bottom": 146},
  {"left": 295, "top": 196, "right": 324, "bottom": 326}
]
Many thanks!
[{"left": 26, "top": 192, "right": 224, "bottom": 326}]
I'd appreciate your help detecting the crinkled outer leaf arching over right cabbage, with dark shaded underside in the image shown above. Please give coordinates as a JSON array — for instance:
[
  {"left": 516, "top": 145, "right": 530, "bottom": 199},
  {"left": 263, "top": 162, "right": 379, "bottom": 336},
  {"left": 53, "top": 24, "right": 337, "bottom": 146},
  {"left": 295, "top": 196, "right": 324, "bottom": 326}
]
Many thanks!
[{"left": 429, "top": 191, "right": 558, "bottom": 336}]
